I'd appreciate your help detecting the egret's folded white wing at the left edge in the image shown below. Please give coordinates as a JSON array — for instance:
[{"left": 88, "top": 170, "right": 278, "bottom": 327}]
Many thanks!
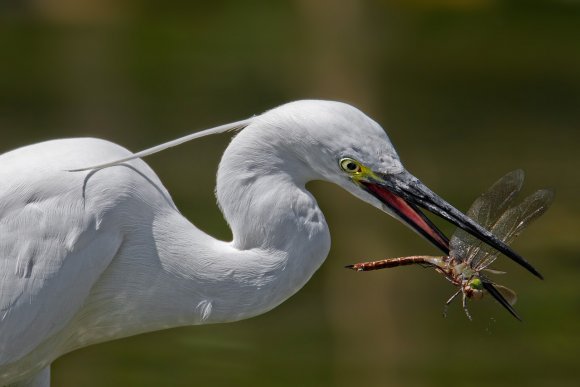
[{"left": 0, "top": 198, "right": 121, "bottom": 364}]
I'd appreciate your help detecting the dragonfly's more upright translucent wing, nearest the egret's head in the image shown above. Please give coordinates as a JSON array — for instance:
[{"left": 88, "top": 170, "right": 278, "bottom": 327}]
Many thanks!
[{"left": 449, "top": 169, "right": 524, "bottom": 262}]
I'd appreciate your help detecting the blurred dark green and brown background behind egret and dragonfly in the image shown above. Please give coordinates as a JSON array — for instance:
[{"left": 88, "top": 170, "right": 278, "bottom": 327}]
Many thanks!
[{"left": 0, "top": 0, "right": 580, "bottom": 387}]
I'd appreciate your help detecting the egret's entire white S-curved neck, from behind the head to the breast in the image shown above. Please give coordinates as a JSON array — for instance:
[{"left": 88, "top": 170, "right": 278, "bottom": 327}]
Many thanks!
[{"left": 67, "top": 127, "right": 330, "bottom": 350}]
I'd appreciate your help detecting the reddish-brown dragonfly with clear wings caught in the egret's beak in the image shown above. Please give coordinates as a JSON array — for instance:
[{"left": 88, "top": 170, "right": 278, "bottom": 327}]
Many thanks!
[{"left": 346, "top": 170, "right": 554, "bottom": 321}]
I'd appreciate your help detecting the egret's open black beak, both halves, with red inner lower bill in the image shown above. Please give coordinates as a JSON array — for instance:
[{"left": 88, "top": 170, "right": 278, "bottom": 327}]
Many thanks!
[{"left": 359, "top": 171, "right": 543, "bottom": 279}]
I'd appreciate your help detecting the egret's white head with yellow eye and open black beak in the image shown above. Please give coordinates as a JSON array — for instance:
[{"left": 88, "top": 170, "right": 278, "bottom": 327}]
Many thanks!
[{"left": 254, "top": 100, "right": 542, "bottom": 278}]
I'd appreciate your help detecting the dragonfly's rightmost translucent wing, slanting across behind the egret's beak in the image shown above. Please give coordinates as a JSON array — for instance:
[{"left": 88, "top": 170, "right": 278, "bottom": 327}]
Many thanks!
[{"left": 471, "top": 189, "right": 554, "bottom": 269}]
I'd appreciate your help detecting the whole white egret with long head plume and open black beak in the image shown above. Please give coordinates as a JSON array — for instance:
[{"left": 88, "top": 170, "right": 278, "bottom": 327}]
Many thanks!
[{"left": 0, "top": 101, "right": 540, "bottom": 386}]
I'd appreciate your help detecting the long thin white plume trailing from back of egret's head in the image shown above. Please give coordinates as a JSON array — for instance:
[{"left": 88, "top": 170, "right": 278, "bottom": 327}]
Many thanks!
[{"left": 67, "top": 118, "right": 254, "bottom": 172}]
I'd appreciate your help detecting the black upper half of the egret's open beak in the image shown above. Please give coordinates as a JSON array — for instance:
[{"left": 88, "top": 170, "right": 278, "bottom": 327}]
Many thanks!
[{"left": 367, "top": 171, "right": 543, "bottom": 279}]
